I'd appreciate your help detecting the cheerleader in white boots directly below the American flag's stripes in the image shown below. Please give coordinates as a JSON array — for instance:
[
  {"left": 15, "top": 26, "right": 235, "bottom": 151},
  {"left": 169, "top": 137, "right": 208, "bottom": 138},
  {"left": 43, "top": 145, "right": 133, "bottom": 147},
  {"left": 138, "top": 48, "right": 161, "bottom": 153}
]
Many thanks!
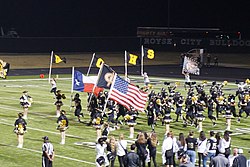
[{"left": 124, "top": 106, "right": 137, "bottom": 139}]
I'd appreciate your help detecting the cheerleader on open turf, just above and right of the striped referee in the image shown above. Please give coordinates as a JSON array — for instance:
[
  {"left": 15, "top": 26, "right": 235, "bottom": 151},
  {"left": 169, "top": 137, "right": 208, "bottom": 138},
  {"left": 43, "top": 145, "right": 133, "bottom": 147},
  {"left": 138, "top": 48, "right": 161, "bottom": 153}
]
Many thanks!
[{"left": 57, "top": 110, "right": 69, "bottom": 144}]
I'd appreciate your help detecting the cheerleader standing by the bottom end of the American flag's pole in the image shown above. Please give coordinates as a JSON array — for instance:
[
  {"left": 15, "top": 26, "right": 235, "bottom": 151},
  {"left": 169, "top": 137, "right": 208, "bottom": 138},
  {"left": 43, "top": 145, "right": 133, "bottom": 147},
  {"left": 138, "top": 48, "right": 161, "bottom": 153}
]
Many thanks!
[{"left": 92, "top": 106, "right": 103, "bottom": 140}]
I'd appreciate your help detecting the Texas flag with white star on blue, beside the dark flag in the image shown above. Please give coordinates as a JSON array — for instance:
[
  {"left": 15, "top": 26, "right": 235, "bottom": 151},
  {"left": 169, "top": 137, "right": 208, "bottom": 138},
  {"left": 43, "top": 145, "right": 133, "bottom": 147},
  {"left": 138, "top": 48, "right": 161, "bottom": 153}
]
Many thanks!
[{"left": 73, "top": 71, "right": 103, "bottom": 95}]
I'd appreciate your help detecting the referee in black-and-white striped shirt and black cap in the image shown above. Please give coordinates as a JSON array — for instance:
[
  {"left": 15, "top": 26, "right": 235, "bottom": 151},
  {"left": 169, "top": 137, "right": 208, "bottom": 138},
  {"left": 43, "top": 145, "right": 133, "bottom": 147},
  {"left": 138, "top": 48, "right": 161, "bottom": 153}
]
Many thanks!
[{"left": 42, "top": 136, "right": 55, "bottom": 167}]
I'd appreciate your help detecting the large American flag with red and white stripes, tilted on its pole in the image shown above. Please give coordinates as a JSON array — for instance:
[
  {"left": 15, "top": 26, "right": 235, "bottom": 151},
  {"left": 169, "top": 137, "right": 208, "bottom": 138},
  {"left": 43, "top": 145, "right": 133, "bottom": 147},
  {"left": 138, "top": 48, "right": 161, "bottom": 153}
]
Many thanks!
[{"left": 109, "top": 74, "right": 148, "bottom": 111}]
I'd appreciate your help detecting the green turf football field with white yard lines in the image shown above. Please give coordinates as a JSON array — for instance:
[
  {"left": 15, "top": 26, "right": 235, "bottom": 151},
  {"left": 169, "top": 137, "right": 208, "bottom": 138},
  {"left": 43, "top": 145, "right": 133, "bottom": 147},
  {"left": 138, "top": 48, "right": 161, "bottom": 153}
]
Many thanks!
[{"left": 0, "top": 75, "right": 250, "bottom": 167}]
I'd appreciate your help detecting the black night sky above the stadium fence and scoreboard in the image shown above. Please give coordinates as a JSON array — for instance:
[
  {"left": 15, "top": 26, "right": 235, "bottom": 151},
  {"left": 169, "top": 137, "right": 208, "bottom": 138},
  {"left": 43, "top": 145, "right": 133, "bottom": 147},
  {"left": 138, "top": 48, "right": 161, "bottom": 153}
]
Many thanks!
[{"left": 0, "top": 0, "right": 250, "bottom": 38}]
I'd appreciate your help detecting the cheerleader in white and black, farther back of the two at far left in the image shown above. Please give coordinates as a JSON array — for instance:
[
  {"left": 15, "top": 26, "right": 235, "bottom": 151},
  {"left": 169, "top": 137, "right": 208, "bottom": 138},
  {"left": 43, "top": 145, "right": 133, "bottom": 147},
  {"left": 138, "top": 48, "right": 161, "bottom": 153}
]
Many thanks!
[{"left": 20, "top": 91, "right": 33, "bottom": 119}]
